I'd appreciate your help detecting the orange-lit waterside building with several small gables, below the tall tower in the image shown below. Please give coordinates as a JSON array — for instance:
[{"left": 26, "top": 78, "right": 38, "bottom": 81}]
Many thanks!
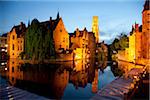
[{"left": 70, "top": 28, "right": 96, "bottom": 59}]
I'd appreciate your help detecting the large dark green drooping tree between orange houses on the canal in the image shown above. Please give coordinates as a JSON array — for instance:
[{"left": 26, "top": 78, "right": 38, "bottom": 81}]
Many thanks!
[{"left": 25, "top": 19, "right": 55, "bottom": 60}]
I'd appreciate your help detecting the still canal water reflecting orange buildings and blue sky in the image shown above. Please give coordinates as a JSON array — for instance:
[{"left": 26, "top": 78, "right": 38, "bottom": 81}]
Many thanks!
[{"left": 0, "top": 59, "right": 122, "bottom": 99}]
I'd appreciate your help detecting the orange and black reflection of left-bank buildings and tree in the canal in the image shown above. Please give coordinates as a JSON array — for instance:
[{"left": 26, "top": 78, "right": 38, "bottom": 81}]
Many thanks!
[{"left": 3, "top": 59, "right": 110, "bottom": 99}]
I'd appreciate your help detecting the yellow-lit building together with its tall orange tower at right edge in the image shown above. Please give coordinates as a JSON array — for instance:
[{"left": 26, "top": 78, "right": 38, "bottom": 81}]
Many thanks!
[{"left": 125, "top": 0, "right": 150, "bottom": 62}]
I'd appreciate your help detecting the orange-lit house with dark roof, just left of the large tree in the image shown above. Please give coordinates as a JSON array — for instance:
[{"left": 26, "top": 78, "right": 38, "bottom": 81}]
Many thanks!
[{"left": 7, "top": 22, "right": 26, "bottom": 58}]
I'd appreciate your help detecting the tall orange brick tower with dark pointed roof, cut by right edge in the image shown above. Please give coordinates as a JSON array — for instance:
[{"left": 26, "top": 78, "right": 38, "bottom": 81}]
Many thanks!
[{"left": 142, "top": 0, "right": 150, "bottom": 59}]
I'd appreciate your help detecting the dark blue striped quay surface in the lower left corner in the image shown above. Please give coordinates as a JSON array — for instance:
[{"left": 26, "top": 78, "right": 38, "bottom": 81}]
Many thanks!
[{"left": 0, "top": 76, "right": 48, "bottom": 100}]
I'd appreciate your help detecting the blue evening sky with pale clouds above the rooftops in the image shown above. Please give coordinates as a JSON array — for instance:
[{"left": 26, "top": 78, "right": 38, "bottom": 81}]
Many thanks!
[{"left": 0, "top": 0, "right": 144, "bottom": 43}]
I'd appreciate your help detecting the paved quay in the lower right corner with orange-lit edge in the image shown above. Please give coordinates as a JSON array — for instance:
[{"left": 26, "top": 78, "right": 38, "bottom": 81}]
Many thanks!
[{"left": 92, "top": 61, "right": 149, "bottom": 100}]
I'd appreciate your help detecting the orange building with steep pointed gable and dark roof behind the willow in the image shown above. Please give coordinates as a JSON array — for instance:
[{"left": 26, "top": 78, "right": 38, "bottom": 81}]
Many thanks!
[{"left": 41, "top": 13, "right": 69, "bottom": 53}]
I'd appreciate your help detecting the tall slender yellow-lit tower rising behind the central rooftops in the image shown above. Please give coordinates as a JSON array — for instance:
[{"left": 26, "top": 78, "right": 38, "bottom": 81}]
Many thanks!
[{"left": 92, "top": 16, "right": 99, "bottom": 43}]
